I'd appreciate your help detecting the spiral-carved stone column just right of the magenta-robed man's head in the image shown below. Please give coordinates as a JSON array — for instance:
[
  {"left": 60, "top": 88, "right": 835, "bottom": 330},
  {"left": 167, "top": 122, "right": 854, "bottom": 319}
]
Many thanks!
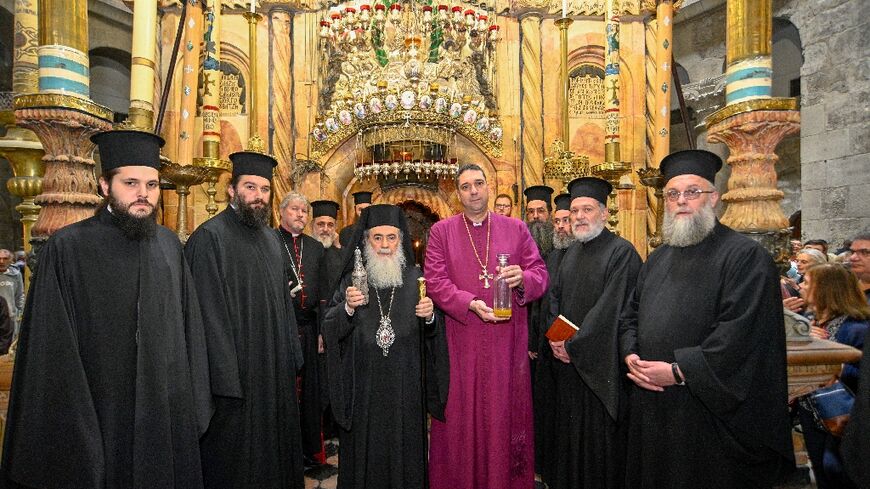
[{"left": 520, "top": 10, "right": 544, "bottom": 187}]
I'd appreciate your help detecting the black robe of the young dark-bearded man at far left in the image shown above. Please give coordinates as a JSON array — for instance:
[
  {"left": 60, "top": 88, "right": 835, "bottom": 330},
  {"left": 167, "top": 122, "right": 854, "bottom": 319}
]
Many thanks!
[{"left": 3, "top": 209, "right": 211, "bottom": 489}]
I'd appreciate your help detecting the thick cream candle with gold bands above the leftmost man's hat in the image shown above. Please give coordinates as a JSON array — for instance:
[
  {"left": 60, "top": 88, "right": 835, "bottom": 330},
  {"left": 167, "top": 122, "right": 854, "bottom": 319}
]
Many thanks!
[{"left": 130, "top": 0, "right": 157, "bottom": 131}]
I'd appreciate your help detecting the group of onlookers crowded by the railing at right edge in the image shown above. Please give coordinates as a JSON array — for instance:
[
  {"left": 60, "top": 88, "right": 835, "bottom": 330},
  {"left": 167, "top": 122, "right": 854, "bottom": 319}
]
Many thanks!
[{"left": 781, "top": 233, "right": 870, "bottom": 489}]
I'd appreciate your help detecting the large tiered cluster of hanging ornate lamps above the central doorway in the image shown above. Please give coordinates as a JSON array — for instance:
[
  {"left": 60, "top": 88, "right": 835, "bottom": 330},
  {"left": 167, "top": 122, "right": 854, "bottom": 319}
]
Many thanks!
[{"left": 311, "top": 0, "right": 503, "bottom": 160}]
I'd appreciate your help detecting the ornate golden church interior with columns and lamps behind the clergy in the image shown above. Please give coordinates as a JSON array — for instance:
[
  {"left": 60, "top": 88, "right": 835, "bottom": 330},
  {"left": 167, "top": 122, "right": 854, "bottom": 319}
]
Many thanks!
[{"left": 0, "top": 0, "right": 870, "bottom": 487}]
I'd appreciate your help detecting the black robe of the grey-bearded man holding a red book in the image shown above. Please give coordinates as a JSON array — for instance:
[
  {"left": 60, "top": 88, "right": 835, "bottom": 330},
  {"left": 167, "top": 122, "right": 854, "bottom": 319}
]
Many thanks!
[{"left": 540, "top": 229, "right": 641, "bottom": 489}]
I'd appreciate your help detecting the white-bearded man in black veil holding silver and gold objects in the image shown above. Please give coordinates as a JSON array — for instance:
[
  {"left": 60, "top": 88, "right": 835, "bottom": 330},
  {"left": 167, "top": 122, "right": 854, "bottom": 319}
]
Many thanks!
[{"left": 323, "top": 205, "right": 448, "bottom": 489}]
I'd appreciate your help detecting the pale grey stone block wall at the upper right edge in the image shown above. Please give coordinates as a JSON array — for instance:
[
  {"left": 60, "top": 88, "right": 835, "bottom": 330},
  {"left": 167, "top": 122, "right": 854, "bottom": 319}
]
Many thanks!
[{"left": 774, "top": 0, "right": 870, "bottom": 245}]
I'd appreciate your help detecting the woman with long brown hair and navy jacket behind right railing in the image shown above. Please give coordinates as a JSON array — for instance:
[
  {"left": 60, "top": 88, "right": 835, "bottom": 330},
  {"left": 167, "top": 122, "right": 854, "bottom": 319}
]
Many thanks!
[{"left": 797, "top": 263, "right": 870, "bottom": 489}]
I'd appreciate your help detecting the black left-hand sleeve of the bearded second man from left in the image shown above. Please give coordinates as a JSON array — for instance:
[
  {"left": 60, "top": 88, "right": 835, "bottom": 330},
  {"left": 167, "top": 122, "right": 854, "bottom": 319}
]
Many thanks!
[{"left": 184, "top": 229, "right": 244, "bottom": 399}]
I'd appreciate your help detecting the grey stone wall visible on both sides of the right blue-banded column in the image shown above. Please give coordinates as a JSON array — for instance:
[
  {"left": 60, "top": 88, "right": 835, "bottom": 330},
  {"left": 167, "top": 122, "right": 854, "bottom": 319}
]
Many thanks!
[{"left": 671, "top": 0, "right": 870, "bottom": 245}]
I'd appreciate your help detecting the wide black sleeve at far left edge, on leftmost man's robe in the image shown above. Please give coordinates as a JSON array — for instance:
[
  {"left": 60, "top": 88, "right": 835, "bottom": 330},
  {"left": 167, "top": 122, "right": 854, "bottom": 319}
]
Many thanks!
[{"left": 2, "top": 240, "right": 105, "bottom": 489}]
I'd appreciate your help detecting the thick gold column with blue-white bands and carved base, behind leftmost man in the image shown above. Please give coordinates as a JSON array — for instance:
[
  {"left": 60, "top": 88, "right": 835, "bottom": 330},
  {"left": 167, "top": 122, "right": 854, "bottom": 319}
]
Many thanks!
[{"left": 15, "top": 0, "right": 113, "bottom": 253}]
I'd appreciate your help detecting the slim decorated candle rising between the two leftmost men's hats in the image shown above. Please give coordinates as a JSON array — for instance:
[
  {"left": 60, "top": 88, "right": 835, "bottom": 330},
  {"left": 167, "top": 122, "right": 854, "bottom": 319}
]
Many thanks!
[{"left": 200, "top": 0, "right": 221, "bottom": 158}]
